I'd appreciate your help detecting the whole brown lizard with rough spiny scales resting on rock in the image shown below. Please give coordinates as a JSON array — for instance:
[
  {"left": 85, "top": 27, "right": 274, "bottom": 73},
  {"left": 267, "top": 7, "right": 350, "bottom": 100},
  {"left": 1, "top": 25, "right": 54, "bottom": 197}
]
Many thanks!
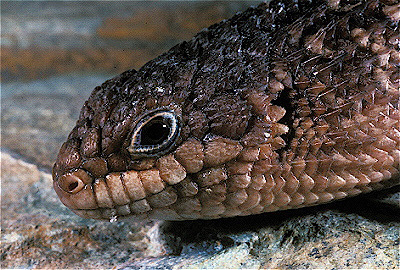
[{"left": 53, "top": 0, "right": 400, "bottom": 220}]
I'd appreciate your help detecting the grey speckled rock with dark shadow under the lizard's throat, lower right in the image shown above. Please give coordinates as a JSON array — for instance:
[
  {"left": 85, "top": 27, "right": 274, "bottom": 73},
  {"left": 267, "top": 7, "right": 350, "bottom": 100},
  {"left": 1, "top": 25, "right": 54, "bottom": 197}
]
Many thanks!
[{"left": 121, "top": 204, "right": 400, "bottom": 269}]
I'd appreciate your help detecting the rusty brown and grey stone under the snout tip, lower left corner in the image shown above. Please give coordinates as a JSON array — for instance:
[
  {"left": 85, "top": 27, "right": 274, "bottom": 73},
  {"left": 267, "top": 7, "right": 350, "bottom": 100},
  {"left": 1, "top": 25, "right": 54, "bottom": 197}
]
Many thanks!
[{"left": 0, "top": 152, "right": 165, "bottom": 269}]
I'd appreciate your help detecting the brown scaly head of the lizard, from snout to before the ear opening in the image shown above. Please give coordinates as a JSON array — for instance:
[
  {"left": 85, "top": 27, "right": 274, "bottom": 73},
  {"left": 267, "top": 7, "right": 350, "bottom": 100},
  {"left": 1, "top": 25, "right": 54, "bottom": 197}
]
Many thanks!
[{"left": 53, "top": 52, "right": 283, "bottom": 220}]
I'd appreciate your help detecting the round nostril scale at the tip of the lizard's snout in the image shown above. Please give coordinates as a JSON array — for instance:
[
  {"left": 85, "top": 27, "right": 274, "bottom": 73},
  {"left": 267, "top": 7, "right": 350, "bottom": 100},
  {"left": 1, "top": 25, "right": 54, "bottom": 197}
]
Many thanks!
[{"left": 58, "top": 170, "right": 92, "bottom": 194}]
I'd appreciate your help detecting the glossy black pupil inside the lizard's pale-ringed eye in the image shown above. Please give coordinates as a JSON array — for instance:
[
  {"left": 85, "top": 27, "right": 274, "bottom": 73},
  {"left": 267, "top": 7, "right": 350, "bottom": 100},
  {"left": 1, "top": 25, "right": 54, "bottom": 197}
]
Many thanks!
[{"left": 140, "top": 116, "right": 170, "bottom": 145}]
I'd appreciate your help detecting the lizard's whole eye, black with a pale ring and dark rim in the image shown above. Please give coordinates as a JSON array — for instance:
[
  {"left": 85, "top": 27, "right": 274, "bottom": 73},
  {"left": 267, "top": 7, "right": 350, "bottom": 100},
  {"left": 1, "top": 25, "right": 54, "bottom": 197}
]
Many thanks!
[{"left": 128, "top": 111, "right": 179, "bottom": 157}]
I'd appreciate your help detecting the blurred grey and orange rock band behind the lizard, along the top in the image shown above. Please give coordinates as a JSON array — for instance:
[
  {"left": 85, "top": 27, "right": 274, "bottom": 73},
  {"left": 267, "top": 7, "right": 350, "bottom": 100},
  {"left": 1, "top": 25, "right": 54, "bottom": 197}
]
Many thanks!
[{"left": 1, "top": 1, "right": 256, "bottom": 82}]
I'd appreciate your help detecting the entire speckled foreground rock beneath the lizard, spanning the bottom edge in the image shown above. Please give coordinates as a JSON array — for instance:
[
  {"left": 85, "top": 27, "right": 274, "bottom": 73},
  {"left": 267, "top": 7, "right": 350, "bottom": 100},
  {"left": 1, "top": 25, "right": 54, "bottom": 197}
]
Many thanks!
[{"left": 1, "top": 151, "right": 400, "bottom": 269}]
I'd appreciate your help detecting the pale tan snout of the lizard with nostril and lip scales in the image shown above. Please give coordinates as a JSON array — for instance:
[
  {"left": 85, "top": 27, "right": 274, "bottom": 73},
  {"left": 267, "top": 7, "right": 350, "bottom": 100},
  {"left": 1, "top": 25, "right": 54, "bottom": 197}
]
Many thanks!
[{"left": 54, "top": 156, "right": 186, "bottom": 220}]
